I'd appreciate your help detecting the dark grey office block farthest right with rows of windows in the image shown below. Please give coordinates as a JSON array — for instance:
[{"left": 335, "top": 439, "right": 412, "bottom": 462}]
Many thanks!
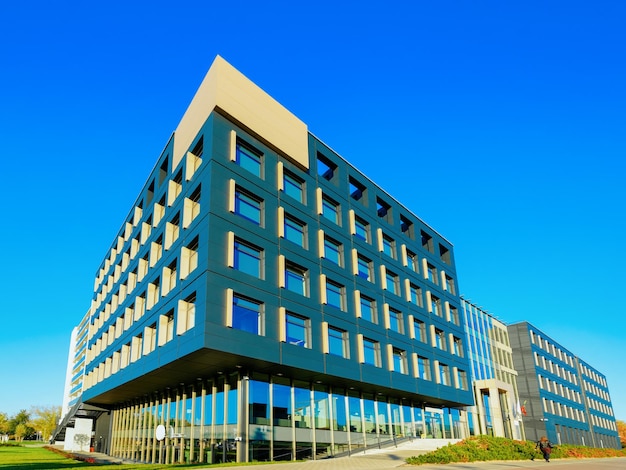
[{"left": 508, "top": 322, "right": 621, "bottom": 449}]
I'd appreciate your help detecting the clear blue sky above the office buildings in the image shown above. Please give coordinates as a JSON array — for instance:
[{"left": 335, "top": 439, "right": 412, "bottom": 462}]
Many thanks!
[{"left": 0, "top": 0, "right": 626, "bottom": 420}]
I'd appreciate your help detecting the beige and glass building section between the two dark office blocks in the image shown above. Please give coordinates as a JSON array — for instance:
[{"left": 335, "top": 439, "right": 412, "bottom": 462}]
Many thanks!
[{"left": 461, "top": 297, "right": 524, "bottom": 440}]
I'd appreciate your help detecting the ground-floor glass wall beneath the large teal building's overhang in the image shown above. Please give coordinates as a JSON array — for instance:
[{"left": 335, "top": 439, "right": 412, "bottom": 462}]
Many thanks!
[{"left": 110, "top": 373, "right": 467, "bottom": 463}]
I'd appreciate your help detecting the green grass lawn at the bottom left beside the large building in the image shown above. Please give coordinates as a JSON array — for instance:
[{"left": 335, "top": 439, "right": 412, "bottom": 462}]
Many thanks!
[{"left": 0, "top": 446, "right": 277, "bottom": 470}]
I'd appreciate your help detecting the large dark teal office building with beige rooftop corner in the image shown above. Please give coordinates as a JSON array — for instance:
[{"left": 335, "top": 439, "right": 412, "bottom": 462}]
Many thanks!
[{"left": 67, "top": 57, "right": 473, "bottom": 463}]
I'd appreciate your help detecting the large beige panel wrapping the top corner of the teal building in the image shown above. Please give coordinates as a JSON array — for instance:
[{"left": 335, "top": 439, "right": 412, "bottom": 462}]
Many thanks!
[{"left": 172, "top": 56, "right": 309, "bottom": 169}]
